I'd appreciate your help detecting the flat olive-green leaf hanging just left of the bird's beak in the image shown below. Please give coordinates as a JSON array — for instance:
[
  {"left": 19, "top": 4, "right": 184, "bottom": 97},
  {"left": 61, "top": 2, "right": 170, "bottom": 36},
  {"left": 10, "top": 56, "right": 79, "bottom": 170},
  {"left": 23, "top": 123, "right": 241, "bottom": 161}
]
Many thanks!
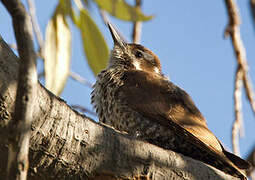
[{"left": 77, "top": 9, "right": 109, "bottom": 75}]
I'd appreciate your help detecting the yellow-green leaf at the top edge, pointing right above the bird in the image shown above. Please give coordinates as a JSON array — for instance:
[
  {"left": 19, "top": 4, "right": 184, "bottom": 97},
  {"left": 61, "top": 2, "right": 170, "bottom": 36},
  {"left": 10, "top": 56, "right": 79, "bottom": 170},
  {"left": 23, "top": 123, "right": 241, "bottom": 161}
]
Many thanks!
[{"left": 94, "top": 0, "right": 153, "bottom": 21}]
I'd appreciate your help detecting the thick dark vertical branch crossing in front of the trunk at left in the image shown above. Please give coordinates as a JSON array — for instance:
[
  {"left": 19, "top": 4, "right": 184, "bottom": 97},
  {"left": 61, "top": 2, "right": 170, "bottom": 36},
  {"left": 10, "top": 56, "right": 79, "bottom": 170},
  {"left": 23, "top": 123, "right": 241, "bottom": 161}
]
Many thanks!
[{"left": 2, "top": 0, "right": 37, "bottom": 180}]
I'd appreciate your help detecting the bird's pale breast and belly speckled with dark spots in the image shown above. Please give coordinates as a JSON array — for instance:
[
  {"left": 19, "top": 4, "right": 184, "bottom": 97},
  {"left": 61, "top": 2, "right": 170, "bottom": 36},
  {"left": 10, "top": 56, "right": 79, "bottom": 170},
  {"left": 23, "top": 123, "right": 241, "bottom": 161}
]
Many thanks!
[{"left": 91, "top": 70, "right": 141, "bottom": 133}]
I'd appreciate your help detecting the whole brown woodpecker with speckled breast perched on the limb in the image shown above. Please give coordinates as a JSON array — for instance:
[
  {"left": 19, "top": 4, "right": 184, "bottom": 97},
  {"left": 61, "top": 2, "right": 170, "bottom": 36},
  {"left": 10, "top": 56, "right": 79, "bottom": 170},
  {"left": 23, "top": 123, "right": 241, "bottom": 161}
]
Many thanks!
[{"left": 92, "top": 24, "right": 249, "bottom": 179}]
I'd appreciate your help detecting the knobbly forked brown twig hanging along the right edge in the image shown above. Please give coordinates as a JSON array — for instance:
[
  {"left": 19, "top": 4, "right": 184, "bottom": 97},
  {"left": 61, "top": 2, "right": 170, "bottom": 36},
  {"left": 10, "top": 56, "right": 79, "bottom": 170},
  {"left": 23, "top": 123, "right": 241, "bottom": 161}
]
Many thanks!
[{"left": 225, "top": 0, "right": 252, "bottom": 153}]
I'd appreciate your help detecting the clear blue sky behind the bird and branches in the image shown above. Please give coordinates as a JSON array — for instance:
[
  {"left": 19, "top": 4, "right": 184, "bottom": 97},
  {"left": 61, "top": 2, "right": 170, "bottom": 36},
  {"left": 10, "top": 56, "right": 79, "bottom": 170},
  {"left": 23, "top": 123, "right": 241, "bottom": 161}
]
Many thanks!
[{"left": 0, "top": 0, "right": 255, "bottom": 157}]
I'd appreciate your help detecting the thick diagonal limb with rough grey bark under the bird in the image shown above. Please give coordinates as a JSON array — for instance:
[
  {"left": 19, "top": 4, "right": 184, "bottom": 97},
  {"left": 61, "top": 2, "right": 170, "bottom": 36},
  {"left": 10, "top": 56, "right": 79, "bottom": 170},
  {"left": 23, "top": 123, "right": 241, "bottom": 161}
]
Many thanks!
[{"left": 0, "top": 35, "right": 240, "bottom": 179}]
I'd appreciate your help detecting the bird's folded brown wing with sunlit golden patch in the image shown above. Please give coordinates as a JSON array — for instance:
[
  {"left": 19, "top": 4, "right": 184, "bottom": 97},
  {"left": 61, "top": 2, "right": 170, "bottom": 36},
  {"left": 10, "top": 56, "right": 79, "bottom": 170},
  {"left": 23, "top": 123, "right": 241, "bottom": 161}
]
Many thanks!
[{"left": 118, "top": 70, "right": 249, "bottom": 172}]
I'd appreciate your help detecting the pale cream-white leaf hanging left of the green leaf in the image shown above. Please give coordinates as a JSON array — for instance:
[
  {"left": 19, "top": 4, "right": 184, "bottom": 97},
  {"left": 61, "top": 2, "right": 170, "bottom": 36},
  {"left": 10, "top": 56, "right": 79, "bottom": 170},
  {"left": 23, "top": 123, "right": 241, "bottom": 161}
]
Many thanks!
[{"left": 44, "top": 6, "right": 71, "bottom": 95}]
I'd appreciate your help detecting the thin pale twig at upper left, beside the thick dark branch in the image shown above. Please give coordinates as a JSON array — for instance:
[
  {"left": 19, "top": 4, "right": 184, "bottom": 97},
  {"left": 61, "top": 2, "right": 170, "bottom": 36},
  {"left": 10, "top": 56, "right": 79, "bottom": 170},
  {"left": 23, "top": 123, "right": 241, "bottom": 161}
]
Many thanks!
[{"left": 27, "top": 0, "right": 44, "bottom": 57}]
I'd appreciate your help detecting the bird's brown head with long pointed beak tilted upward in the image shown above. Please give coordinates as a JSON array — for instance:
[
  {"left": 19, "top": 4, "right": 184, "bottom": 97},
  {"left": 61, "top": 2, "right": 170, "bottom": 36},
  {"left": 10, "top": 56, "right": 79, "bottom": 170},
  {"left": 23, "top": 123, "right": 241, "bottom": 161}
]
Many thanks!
[{"left": 108, "top": 23, "right": 161, "bottom": 74}]
